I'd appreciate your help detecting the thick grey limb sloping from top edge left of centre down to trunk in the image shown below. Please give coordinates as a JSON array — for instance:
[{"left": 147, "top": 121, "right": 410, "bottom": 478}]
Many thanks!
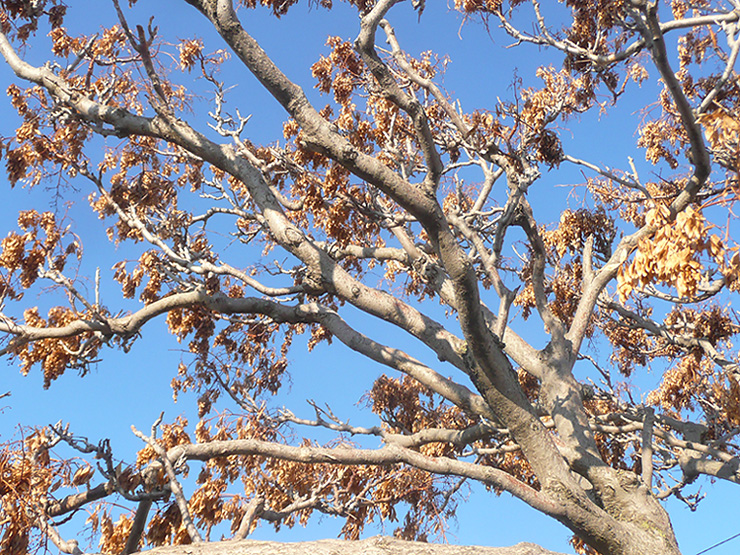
[{"left": 175, "top": 5, "right": 632, "bottom": 543}]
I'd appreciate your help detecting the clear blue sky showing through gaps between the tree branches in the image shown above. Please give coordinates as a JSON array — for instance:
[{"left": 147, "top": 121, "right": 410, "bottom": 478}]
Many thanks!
[{"left": 0, "top": 0, "right": 740, "bottom": 555}]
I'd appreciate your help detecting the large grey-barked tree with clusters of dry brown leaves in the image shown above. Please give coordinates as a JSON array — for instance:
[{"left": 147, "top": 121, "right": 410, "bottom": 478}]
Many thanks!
[{"left": 0, "top": 0, "right": 740, "bottom": 555}]
